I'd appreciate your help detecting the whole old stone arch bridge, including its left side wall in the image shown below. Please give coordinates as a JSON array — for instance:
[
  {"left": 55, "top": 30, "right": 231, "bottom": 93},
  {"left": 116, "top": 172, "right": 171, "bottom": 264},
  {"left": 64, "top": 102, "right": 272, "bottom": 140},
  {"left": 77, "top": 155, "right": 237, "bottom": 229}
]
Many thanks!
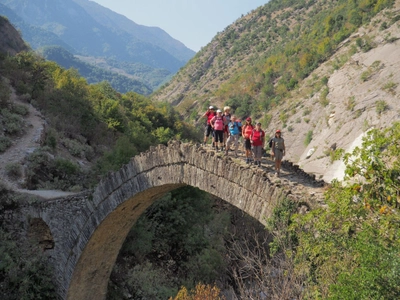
[{"left": 10, "top": 141, "right": 320, "bottom": 300}]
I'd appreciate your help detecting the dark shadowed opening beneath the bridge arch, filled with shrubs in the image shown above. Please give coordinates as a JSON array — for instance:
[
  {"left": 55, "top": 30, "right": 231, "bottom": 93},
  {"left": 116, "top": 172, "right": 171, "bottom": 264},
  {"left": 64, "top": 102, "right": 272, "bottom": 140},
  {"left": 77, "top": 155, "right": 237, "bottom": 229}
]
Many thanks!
[{"left": 107, "top": 186, "right": 271, "bottom": 299}]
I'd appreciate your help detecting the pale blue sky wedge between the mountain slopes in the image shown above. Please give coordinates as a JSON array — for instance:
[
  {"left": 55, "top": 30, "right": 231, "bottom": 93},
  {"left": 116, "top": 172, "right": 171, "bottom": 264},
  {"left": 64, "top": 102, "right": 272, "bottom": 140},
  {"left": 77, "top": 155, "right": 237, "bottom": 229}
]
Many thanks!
[{"left": 91, "top": 0, "right": 268, "bottom": 52}]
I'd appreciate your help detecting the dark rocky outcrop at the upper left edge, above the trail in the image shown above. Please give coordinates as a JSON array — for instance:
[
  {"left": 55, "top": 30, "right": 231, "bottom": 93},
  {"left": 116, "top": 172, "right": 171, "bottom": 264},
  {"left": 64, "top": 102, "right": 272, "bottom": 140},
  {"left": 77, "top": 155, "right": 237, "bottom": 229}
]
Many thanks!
[{"left": 0, "top": 16, "right": 29, "bottom": 55}]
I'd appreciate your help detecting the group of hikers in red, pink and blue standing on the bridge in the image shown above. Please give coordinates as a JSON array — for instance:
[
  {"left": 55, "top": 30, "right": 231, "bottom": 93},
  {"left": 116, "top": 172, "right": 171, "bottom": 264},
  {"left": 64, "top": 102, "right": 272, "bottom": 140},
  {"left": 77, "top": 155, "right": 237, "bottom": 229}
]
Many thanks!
[{"left": 203, "top": 106, "right": 286, "bottom": 176}]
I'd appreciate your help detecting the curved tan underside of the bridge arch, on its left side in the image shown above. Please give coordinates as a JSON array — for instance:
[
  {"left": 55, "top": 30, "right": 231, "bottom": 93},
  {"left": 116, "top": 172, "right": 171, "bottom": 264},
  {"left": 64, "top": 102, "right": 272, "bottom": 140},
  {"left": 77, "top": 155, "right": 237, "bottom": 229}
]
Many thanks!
[{"left": 67, "top": 184, "right": 184, "bottom": 300}]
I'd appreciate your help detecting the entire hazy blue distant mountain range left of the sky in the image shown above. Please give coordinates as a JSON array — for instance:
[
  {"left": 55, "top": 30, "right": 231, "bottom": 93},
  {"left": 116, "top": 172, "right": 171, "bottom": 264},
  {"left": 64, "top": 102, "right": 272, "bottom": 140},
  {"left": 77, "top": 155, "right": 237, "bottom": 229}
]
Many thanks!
[{"left": 0, "top": 0, "right": 195, "bottom": 92}]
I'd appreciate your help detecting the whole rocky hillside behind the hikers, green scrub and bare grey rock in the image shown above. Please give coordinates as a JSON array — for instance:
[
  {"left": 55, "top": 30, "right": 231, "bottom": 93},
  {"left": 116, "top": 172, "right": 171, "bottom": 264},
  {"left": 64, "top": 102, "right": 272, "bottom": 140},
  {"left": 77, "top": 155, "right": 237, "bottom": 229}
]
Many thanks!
[{"left": 153, "top": 0, "right": 400, "bottom": 181}]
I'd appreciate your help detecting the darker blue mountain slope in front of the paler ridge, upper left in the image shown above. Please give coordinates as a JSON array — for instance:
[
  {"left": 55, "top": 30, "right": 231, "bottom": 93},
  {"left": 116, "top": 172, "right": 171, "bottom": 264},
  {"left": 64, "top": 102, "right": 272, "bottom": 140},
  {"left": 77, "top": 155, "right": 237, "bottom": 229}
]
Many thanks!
[{"left": 0, "top": 0, "right": 194, "bottom": 72}]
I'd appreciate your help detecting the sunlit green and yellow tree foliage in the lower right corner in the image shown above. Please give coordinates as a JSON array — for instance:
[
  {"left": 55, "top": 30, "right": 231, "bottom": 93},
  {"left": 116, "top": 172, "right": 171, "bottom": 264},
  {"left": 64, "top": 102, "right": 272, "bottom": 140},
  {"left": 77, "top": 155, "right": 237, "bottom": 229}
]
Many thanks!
[{"left": 292, "top": 123, "right": 400, "bottom": 299}]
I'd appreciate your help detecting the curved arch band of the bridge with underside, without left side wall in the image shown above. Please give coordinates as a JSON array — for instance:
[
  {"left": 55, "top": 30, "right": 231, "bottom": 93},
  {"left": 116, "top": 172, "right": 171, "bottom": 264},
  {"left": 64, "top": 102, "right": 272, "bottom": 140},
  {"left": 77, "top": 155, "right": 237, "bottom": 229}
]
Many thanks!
[{"left": 62, "top": 142, "right": 290, "bottom": 300}]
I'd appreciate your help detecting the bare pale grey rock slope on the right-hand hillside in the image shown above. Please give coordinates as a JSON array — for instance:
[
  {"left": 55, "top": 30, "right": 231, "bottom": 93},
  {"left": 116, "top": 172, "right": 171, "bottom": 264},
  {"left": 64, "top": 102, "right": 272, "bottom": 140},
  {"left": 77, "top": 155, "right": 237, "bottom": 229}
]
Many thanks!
[{"left": 274, "top": 5, "right": 400, "bottom": 182}]
